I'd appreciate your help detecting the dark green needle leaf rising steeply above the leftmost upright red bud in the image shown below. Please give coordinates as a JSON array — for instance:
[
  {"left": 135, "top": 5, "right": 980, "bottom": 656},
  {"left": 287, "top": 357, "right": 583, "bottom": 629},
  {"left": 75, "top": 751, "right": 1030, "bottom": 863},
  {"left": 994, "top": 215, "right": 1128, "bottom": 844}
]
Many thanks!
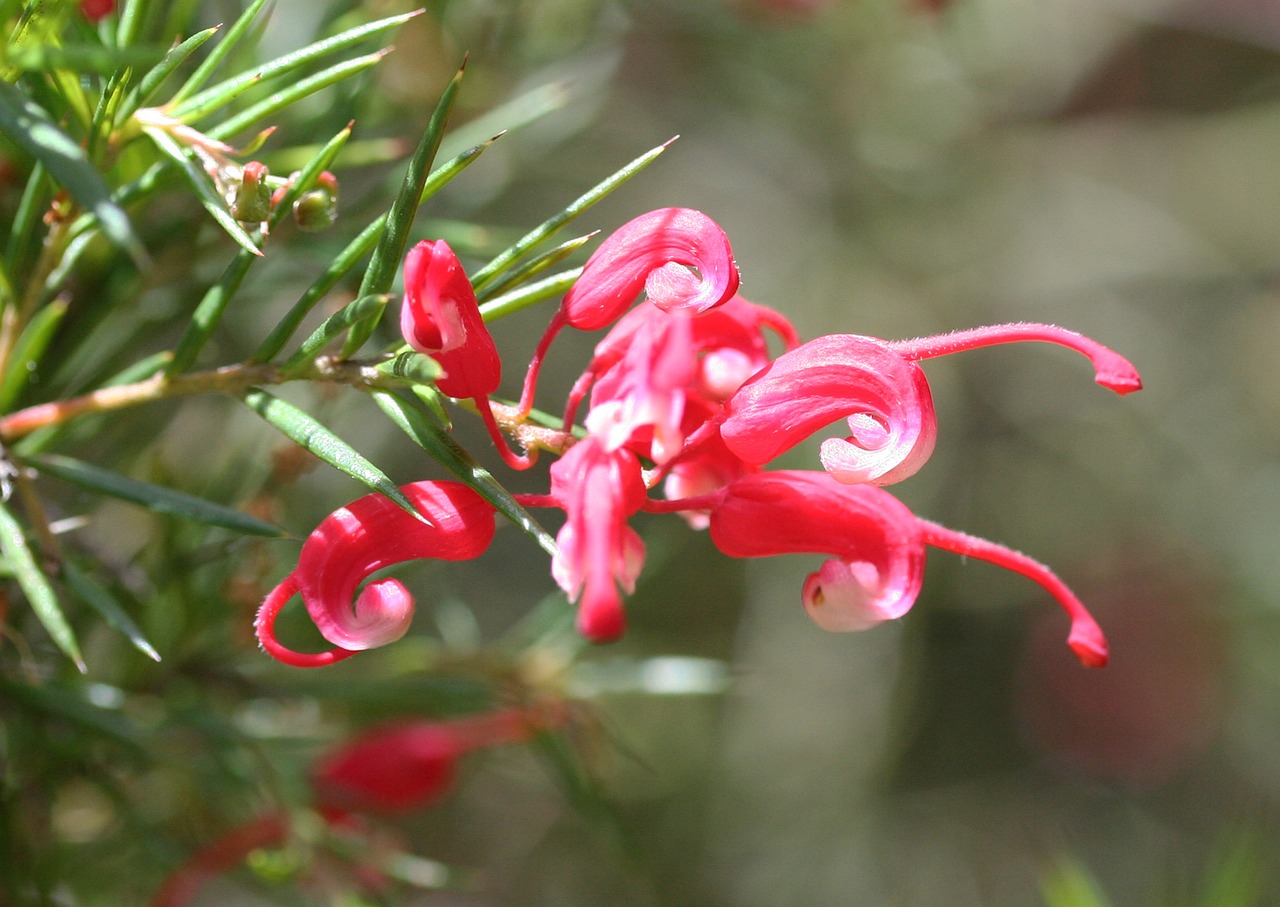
[{"left": 343, "top": 60, "right": 466, "bottom": 356}]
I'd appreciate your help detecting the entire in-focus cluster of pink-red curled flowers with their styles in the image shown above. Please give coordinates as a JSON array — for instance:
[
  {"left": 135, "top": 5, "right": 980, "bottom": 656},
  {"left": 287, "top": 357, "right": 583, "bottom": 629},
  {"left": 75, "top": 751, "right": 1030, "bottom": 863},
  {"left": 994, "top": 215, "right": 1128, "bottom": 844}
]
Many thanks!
[{"left": 257, "top": 209, "right": 1142, "bottom": 666}]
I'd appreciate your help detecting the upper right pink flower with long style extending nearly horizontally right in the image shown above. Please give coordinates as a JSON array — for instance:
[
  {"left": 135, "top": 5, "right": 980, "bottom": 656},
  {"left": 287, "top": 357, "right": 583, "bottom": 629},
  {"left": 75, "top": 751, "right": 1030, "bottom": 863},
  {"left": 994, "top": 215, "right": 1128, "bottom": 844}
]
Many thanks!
[{"left": 721, "top": 324, "right": 1142, "bottom": 485}]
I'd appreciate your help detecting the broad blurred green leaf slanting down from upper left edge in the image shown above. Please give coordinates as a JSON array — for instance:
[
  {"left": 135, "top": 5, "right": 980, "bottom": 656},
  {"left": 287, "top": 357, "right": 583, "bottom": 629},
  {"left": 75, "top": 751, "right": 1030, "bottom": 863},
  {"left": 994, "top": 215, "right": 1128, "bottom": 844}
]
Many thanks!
[{"left": 0, "top": 82, "right": 146, "bottom": 262}]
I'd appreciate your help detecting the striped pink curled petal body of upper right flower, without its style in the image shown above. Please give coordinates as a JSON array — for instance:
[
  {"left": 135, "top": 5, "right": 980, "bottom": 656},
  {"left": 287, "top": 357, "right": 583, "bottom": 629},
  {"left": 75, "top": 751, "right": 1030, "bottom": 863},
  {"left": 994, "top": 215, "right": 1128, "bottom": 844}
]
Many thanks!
[{"left": 721, "top": 334, "right": 937, "bottom": 485}]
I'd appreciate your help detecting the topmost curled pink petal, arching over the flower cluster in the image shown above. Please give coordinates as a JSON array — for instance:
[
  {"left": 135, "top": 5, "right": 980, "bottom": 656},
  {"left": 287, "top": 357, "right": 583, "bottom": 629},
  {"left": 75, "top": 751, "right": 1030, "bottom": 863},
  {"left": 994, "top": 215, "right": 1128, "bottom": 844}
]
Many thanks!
[{"left": 561, "top": 207, "right": 739, "bottom": 330}]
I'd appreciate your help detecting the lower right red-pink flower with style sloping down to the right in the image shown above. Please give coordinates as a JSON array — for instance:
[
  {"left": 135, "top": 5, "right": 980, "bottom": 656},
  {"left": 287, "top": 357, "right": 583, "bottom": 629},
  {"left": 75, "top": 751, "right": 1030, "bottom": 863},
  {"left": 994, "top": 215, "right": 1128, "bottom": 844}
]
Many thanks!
[{"left": 710, "top": 471, "right": 1108, "bottom": 666}]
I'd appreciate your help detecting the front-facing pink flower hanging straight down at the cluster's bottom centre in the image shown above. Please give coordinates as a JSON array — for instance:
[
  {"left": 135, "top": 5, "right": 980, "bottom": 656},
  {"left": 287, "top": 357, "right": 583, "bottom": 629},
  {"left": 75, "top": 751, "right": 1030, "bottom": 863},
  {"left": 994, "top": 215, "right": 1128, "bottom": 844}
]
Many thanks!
[{"left": 540, "top": 436, "right": 645, "bottom": 642}]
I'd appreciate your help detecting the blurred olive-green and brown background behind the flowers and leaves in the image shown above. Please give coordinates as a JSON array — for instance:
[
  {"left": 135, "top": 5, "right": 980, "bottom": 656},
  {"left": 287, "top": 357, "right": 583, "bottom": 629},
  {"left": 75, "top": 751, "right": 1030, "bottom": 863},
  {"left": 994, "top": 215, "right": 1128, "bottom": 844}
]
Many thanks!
[{"left": 15, "top": 0, "right": 1280, "bottom": 907}]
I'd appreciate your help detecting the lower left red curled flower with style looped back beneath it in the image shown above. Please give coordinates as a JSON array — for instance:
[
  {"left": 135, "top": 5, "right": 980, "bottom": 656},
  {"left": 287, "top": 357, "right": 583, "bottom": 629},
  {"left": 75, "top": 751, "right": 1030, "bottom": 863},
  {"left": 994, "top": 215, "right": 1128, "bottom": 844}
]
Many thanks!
[{"left": 255, "top": 481, "right": 494, "bottom": 668}]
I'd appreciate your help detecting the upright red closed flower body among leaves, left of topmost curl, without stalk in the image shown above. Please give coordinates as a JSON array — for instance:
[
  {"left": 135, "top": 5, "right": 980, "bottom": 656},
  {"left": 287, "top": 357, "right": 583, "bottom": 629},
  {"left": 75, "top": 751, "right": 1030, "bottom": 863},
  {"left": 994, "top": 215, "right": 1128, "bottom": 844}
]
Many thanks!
[{"left": 401, "top": 239, "right": 502, "bottom": 399}]
